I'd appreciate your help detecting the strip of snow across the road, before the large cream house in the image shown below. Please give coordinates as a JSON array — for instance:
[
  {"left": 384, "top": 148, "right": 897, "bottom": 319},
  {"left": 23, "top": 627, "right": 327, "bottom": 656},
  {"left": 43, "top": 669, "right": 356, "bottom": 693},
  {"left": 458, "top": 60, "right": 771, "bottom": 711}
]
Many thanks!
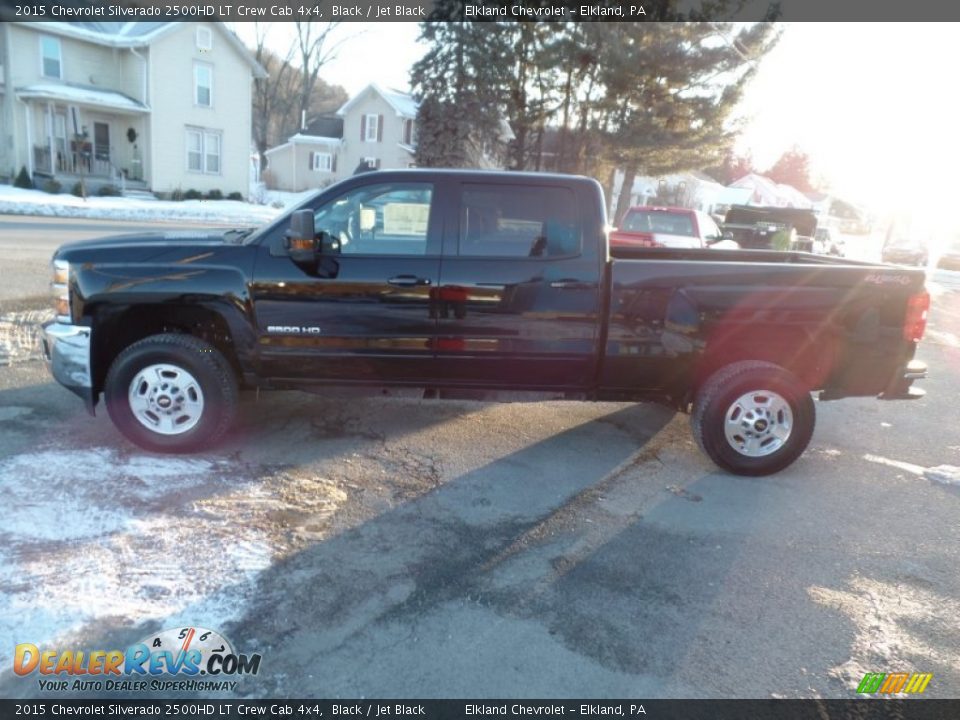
[{"left": 0, "top": 185, "right": 315, "bottom": 225}]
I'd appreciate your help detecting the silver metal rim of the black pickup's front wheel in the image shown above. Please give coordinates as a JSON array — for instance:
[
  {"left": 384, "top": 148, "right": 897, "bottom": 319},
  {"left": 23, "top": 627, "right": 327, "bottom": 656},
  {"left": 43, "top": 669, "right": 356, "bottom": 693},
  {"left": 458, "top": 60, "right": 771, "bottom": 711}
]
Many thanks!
[{"left": 127, "top": 363, "right": 203, "bottom": 435}]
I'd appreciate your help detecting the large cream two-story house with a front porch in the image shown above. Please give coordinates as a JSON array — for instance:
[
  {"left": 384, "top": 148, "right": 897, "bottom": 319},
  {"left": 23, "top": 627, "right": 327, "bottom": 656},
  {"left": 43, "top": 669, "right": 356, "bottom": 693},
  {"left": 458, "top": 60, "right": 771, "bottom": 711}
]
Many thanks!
[{"left": 0, "top": 22, "right": 266, "bottom": 195}]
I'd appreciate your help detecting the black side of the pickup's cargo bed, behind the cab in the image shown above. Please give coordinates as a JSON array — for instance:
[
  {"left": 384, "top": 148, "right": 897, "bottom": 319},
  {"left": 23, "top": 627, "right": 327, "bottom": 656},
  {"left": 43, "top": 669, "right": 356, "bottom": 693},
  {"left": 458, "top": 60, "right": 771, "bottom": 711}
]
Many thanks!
[{"left": 600, "top": 248, "right": 925, "bottom": 398}]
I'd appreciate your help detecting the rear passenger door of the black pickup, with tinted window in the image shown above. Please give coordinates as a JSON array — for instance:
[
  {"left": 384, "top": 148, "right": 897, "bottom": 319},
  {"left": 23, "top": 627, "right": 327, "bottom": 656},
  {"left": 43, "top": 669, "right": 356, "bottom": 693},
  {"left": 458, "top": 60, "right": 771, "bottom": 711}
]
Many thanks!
[{"left": 433, "top": 179, "right": 600, "bottom": 389}]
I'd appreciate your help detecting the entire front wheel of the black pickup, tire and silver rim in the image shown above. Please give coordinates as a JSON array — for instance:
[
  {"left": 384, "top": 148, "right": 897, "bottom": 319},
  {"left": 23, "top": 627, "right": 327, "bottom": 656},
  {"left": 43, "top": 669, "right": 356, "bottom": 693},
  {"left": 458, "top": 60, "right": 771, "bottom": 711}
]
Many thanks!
[{"left": 104, "top": 333, "right": 237, "bottom": 452}]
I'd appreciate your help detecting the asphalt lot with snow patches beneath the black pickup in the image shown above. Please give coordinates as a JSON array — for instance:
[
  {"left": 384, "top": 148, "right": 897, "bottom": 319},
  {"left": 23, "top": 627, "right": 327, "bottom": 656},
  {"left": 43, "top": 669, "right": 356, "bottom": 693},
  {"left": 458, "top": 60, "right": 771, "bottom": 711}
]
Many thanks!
[{"left": 0, "top": 219, "right": 960, "bottom": 698}]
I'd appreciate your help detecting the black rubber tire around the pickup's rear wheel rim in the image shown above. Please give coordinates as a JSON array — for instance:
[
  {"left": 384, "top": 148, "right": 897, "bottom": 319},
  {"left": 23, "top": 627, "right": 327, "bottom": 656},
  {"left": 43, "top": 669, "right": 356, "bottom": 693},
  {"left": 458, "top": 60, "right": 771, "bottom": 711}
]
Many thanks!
[{"left": 690, "top": 360, "right": 816, "bottom": 476}]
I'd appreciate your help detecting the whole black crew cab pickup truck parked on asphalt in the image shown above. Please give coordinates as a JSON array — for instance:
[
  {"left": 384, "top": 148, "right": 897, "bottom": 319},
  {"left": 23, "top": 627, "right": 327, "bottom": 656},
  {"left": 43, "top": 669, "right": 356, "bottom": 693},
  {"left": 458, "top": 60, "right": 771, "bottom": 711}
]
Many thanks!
[{"left": 42, "top": 170, "right": 929, "bottom": 475}]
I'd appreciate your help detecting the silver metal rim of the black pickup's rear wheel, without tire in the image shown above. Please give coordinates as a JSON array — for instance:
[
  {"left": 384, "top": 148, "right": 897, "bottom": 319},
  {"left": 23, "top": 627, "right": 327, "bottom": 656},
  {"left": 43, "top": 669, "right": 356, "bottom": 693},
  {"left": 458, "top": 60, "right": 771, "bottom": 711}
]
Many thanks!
[{"left": 723, "top": 390, "right": 793, "bottom": 457}]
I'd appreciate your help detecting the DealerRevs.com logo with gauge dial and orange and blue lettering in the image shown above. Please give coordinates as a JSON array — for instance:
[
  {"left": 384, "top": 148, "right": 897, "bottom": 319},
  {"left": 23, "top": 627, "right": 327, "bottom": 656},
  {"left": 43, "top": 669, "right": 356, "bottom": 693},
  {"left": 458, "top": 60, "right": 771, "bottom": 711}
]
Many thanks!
[{"left": 13, "top": 627, "right": 260, "bottom": 692}]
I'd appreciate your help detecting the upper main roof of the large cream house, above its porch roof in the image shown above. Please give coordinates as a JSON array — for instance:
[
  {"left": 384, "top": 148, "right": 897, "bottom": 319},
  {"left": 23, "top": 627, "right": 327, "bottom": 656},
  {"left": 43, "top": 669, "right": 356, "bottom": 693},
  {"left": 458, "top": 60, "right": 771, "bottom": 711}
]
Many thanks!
[{"left": 17, "top": 21, "right": 267, "bottom": 78}]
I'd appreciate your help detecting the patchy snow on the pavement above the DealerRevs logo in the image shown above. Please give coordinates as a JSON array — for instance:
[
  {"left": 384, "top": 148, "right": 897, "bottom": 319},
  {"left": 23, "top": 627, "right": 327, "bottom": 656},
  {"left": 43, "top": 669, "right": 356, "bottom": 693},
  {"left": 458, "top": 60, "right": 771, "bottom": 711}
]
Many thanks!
[{"left": 0, "top": 448, "right": 346, "bottom": 667}]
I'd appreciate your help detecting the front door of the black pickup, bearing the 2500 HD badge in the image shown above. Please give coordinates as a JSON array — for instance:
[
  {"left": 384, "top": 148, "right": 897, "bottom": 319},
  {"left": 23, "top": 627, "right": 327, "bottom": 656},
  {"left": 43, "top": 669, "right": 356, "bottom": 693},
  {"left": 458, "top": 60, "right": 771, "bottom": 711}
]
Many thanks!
[{"left": 252, "top": 175, "right": 441, "bottom": 384}]
